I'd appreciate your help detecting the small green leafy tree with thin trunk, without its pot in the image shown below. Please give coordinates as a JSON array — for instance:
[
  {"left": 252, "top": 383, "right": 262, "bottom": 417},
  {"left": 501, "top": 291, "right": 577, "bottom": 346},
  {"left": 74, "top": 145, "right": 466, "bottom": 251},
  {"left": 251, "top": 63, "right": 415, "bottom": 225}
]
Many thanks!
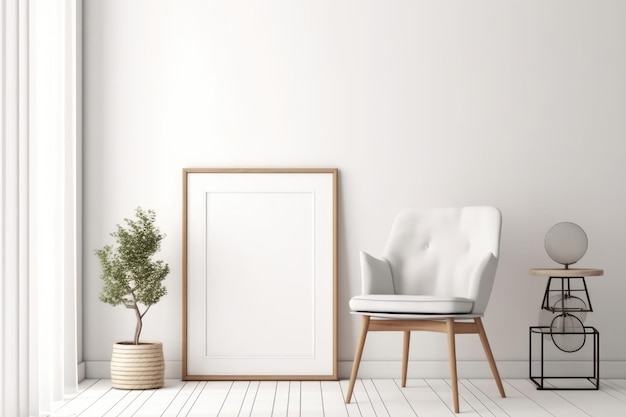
[{"left": 95, "top": 207, "right": 170, "bottom": 345}]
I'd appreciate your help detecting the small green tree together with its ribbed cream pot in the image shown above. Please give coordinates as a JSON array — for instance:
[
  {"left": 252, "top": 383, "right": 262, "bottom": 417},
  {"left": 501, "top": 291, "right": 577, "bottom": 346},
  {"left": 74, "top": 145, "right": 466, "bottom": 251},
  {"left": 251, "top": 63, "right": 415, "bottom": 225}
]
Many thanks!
[{"left": 95, "top": 207, "right": 169, "bottom": 389}]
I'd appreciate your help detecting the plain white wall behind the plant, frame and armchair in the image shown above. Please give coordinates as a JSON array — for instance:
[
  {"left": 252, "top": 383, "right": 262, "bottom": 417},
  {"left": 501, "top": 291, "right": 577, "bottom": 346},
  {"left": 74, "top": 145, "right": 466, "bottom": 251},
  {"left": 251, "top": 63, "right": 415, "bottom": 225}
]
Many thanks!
[{"left": 83, "top": 0, "right": 626, "bottom": 377}]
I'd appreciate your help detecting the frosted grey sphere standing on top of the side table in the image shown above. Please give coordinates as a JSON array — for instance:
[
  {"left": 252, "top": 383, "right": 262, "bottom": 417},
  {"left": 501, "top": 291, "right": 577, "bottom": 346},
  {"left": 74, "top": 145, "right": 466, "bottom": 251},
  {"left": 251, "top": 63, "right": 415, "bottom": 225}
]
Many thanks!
[{"left": 544, "top": 222, "right": 588, "bottom": 268}]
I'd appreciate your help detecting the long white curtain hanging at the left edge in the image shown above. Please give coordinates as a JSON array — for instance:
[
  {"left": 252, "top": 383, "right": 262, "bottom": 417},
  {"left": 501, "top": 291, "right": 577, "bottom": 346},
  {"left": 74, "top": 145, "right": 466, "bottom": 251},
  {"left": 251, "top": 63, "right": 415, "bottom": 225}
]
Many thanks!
[{"left": 0, "top": 0, "right": 81, "bottom": 417}]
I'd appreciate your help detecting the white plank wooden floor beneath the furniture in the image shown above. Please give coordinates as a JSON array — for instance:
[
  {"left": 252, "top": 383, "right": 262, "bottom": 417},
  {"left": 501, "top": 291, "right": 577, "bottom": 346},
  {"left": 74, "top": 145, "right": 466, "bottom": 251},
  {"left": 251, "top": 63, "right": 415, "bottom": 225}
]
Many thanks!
[{"left": 51, "top": 379, "right": 626, "bottom": 417}]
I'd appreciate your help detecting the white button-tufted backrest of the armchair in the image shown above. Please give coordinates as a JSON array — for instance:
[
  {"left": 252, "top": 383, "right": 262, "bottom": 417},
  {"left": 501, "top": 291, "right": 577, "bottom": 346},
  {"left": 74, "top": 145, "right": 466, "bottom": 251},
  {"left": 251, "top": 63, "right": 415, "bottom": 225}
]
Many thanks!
[{"left": 383, "top": 206, "right": 502, "bottom": 314}]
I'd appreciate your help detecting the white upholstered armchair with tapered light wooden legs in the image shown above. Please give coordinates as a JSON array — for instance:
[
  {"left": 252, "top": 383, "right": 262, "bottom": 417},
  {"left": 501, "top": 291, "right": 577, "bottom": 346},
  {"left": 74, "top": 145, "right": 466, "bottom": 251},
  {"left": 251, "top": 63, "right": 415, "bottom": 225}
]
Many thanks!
[{"left": 346, "top": 207, "right": 505, "bottom": 413}]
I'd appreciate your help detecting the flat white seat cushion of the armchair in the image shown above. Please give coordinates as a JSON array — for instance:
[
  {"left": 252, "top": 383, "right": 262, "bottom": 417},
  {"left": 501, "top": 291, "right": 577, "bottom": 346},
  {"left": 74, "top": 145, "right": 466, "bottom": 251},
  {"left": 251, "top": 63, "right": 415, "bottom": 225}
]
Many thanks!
[{"left": 350, "top": 294, "right": 474, "bottom": 314}]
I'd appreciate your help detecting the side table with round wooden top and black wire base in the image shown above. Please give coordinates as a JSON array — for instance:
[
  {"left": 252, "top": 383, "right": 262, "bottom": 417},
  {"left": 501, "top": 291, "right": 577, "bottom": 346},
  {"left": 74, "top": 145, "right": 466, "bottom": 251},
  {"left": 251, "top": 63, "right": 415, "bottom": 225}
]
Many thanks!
[{"left": 529, "top": 268, "right": 604, "bottom": 390}]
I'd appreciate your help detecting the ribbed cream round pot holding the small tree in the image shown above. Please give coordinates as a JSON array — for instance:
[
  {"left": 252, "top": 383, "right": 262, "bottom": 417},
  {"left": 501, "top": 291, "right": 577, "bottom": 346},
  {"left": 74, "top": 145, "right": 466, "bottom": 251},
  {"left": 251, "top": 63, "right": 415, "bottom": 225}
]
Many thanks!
[{"left": 111, "top": 342, "right": 165, "bottom": 389}]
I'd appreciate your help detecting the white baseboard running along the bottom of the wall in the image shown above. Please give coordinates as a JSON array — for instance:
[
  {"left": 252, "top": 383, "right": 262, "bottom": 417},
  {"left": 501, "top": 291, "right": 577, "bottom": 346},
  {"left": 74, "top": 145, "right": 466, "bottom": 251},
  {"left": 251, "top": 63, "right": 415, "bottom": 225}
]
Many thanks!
[{"left": 79, "top": 360, "right": 626, "bottom": 379}]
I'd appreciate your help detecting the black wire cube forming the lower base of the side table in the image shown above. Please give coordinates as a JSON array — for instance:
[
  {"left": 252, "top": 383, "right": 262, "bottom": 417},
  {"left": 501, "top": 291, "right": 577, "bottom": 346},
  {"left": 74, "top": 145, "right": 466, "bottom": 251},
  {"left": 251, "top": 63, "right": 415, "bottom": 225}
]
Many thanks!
[{"left": 528, "top": 326, "right": 600, "bottom": 390}]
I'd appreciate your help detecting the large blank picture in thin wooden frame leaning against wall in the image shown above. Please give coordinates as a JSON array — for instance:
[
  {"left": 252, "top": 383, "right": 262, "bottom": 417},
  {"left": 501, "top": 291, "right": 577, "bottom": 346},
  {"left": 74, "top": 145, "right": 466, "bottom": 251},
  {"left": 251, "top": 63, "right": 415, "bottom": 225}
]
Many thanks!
[{"left": 183, "top": 168, "right": 338, "bottom": 380}]
